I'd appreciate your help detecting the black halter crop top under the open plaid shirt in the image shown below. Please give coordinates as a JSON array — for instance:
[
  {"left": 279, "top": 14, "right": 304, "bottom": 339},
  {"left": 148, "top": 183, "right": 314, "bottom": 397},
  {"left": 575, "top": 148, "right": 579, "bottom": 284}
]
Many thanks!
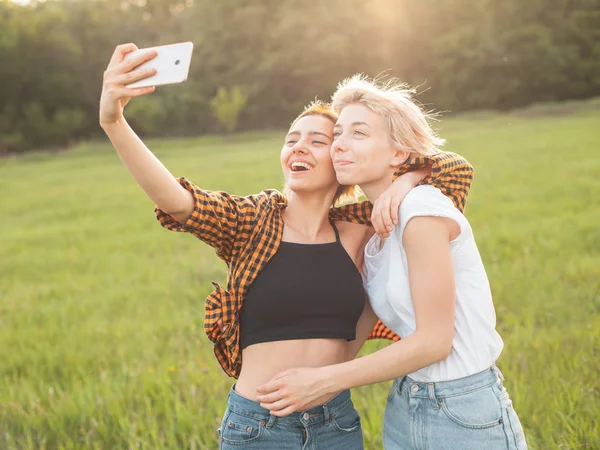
[{"left": 240, "top": 223, "right": 366, "bottom": 349}]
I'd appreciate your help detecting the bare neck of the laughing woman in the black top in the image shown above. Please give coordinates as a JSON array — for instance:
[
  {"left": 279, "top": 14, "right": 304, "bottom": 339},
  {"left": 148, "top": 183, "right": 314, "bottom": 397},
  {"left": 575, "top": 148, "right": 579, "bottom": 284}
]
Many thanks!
[{"left": 283, "top": 192, "right": 334, "bottom": 239}]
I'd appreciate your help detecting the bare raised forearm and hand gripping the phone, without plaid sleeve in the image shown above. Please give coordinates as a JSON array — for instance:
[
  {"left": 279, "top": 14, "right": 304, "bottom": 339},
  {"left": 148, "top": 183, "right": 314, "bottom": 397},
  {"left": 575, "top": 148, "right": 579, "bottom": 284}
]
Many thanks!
[{"left": 99, "top": 44, "right": 194, "bottom": 223}]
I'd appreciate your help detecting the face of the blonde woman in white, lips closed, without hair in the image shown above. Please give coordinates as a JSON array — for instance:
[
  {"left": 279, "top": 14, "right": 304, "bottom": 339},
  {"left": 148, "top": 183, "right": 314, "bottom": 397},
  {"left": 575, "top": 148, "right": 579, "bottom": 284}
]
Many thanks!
[{"left": 331, "top": 103, "right": 408, "bottom": 193}]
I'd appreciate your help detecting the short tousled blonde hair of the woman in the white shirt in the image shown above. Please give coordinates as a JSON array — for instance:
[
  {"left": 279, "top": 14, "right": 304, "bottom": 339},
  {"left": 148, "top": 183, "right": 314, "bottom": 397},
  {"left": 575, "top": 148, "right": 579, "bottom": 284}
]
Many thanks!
[{"left": 332, "top": 74, "right": 445, "bottom": 155}]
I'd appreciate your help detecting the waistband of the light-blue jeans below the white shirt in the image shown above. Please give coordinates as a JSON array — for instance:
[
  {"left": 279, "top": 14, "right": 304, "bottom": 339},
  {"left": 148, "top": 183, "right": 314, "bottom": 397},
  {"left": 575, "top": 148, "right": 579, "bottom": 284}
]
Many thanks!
[{"left": 393, "top": 365, "right": 504, "bottom": 398}]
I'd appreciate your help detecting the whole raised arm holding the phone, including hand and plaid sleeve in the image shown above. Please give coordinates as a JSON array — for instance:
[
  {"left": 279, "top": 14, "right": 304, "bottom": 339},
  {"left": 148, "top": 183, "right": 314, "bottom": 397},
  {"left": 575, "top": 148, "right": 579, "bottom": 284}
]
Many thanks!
[{"left": 100, "top": 44, "right": 269, "bottom": 263}]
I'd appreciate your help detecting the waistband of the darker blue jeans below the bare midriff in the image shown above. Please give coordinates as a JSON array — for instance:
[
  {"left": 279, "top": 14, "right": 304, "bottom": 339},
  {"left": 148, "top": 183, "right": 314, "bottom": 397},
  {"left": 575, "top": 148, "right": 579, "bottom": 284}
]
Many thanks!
[{"left": 227, "top": 385, "right": 353, "bottom": 428}]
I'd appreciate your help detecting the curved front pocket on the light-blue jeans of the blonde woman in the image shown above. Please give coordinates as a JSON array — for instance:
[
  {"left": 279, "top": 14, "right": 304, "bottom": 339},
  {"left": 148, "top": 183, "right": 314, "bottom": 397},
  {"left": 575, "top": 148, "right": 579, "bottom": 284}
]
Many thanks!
[{"left": 439, "top": 387, "right": 503, "bottom": 429}]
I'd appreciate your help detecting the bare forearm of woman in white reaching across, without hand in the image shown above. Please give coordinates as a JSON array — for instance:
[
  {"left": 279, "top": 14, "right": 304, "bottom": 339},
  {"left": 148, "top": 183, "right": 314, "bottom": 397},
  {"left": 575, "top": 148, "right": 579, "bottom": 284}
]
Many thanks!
[{"left": 320, "top": 331, "right": 449, "bottom": 394}]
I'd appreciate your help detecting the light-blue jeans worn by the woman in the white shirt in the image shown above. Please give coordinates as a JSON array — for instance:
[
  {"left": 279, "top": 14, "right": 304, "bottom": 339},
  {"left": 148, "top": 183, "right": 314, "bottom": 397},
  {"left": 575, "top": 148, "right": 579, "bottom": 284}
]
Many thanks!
[{"left": 383, "top": 366, "right": 527, "bottom": 450}]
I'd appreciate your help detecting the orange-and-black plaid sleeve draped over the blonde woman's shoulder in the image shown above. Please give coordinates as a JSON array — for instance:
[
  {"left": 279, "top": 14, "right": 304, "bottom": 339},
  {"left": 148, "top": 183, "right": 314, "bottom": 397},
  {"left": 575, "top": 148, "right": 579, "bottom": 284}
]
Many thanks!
[{"left": 394, "top": 152, "right": 474, "bottom": 211}]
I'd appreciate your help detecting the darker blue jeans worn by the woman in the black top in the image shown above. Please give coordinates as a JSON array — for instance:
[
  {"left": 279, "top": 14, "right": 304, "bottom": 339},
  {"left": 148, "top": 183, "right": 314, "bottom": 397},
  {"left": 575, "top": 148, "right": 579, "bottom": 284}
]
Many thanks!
[{"left": 219, "top": 388, "right": 363, "bottom": 450}]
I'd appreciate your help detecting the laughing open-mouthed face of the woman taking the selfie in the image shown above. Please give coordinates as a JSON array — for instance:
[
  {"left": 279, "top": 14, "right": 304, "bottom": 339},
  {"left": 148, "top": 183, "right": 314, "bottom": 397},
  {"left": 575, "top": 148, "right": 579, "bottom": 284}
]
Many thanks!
[{"left": 281, "top": 115, "right": 339, "bottom": 194}]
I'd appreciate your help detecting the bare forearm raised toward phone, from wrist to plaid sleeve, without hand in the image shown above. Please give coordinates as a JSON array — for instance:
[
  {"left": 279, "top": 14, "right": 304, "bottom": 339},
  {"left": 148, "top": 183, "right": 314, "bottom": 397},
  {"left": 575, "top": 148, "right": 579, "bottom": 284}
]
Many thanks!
[{"left": 103, "top": 118, "right": 194, "bottom": 222}]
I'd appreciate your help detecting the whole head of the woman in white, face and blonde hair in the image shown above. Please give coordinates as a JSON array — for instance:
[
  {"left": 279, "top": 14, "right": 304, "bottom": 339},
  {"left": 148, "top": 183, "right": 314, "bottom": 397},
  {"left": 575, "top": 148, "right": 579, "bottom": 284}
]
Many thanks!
[{"left": 331, "top": 74, "right": 444, "bottom": 199}]
